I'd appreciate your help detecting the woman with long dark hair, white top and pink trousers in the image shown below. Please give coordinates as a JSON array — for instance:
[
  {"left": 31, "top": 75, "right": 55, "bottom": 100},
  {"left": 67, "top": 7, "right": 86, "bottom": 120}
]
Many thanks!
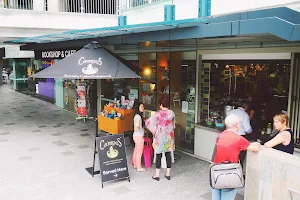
[{"left": 133, "top": 103, "right": 145, "bottom": 172}]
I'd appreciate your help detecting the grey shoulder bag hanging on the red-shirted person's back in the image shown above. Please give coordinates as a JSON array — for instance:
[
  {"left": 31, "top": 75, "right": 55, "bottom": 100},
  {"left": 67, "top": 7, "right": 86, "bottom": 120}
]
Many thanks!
[{"left": 209, "top": 135, "right": 245, "bottom": 189}]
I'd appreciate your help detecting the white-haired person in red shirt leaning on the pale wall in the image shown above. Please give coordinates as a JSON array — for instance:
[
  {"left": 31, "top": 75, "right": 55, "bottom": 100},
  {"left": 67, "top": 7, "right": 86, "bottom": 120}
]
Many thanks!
[{"left": 212, "top": 114, "right": 260, "bottom": 200}]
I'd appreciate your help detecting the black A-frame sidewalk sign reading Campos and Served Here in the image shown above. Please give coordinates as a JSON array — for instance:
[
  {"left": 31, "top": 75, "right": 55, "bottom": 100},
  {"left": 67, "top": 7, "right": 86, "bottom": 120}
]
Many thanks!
[{"left": 96, "top": 135, "right": 130, "bottom": 188}]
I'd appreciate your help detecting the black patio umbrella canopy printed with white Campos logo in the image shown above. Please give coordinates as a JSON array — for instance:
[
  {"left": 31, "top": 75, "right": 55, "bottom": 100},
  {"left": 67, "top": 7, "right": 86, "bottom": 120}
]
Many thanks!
[{"left": 33, "top": 42, "right": 140, "bottom": 79}]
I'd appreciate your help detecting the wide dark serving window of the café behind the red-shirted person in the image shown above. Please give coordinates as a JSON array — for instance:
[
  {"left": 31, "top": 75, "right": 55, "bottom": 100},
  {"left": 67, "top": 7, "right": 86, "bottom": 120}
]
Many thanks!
[{"left": 199, "top": 60, "right": 290, "bottom": 132}]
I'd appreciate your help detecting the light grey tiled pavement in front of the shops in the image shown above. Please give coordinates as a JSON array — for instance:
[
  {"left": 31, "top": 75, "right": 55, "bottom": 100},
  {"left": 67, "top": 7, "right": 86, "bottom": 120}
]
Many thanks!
[{"left": 0, "top": 85, "right": 242, "bottom": 200}]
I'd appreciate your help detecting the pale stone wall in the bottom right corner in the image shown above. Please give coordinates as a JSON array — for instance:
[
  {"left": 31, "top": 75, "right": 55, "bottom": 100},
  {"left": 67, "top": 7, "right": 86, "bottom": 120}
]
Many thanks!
[{"left": 245, "top": 147, "right": 300, "bottom": 200}]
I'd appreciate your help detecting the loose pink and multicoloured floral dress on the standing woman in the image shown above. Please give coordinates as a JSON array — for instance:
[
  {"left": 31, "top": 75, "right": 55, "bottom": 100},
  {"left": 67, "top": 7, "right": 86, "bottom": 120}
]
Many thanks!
[{"left": 145, "top": 110, "right": 175, "bottom": 154}]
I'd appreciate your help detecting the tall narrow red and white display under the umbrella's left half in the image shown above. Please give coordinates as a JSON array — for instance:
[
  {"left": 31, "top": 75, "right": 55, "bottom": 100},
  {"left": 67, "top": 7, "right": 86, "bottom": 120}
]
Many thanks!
[{"left": 76, "top": 82, "right": 87, "bottom": 116}]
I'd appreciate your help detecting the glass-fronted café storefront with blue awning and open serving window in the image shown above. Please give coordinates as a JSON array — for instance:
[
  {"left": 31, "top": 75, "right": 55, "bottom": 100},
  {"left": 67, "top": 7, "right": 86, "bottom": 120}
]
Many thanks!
[{"left": 12, "top": 5, "right": 300, "bottom": 156}]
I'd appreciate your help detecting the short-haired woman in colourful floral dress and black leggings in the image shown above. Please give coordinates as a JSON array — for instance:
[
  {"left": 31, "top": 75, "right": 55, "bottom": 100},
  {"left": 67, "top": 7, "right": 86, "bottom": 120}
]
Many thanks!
[{"left": 146, "top": 98, "right": 175, "bottom": 181}]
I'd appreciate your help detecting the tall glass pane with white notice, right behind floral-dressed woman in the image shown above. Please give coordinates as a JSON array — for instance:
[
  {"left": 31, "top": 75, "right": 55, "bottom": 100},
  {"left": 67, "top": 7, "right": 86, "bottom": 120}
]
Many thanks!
[{"left": 170, "top": 51, "right": 196, "bottom": 153}]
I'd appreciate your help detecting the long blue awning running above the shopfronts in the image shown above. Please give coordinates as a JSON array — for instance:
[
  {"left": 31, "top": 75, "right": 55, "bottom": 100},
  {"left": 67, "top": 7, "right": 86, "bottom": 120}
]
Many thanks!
[{"left": 8, "top": 7, "right": 300, "bottom": 50}]
